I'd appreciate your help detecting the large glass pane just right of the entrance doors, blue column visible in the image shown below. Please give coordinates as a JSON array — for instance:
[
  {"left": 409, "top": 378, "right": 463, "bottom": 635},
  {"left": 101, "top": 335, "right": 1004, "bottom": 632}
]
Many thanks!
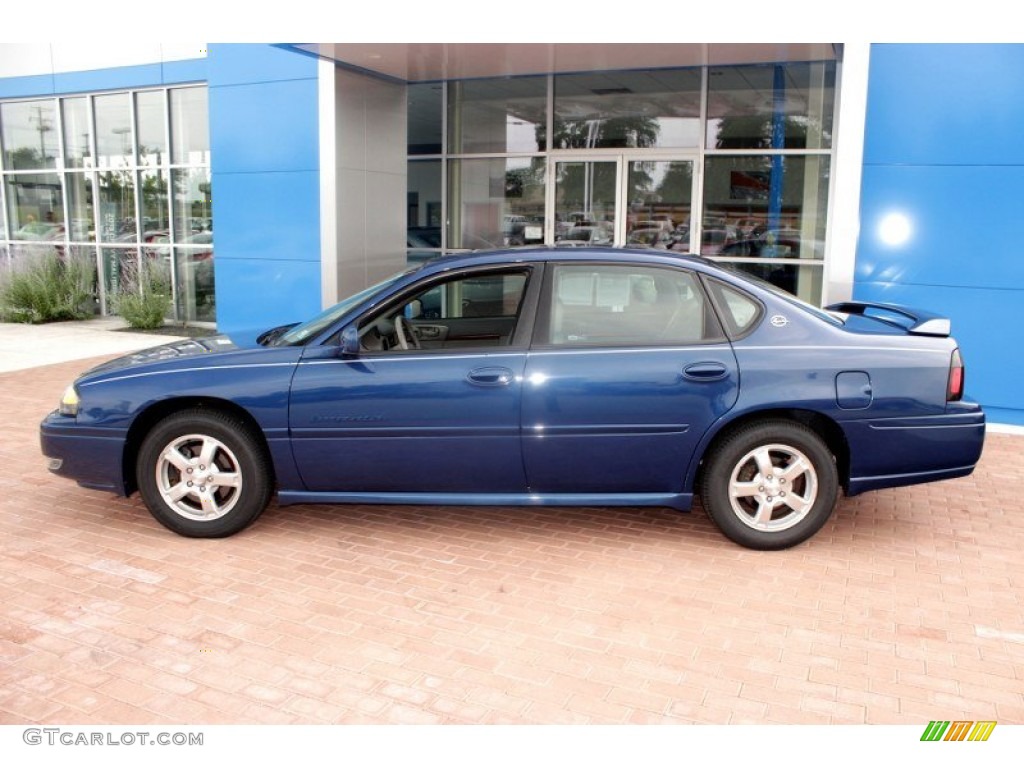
[{"left": 700, "top": 155, "right": 829, "bottom": 259}]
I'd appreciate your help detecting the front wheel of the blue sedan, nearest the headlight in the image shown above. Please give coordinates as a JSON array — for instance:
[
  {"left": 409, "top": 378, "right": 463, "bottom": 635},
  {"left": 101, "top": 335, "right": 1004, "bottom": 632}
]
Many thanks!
[{"left": 136, "top": 409, "right": 272, "bottom": 539}]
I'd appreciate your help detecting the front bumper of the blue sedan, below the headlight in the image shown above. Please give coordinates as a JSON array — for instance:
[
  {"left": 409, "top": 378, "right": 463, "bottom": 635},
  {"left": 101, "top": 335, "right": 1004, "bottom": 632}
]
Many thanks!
[{"left": 39, "top": 411, "right": 126, "bottom": 496}]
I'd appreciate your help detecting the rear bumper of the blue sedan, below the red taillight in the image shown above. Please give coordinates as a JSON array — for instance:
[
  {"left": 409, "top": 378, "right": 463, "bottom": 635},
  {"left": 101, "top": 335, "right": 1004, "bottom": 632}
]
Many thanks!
[{"left": 843, "top": 402, "right": 985, "bottom": 496}]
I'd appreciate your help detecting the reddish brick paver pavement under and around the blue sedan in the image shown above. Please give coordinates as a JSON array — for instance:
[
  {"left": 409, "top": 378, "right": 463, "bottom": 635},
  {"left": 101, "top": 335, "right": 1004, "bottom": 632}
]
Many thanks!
[{"left": 0, "top": 360, "right": 1024, "bottom": 725}]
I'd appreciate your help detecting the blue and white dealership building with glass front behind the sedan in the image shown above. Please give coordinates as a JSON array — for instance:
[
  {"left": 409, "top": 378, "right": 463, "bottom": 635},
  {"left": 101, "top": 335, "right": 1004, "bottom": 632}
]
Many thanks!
[{"left": 0, "top": 43, "right": 1024, "bottom": 426}]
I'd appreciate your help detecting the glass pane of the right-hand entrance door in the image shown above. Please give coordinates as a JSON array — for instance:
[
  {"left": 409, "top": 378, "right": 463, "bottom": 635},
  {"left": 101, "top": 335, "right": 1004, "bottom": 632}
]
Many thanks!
[{"left": 626, "top": 160, "right": 693, "bottom": 251}]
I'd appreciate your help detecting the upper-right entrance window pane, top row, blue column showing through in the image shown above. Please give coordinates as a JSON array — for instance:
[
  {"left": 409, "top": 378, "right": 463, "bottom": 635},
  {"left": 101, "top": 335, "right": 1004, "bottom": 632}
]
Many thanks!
[{"left": 707, "top": 61, "right": 836, "bottom": 150}]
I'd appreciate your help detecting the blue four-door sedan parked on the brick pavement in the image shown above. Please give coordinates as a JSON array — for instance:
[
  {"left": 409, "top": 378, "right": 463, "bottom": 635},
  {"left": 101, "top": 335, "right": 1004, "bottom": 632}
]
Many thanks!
[{"left": 41, "top": 248, "right": 984, "bottom": 550}]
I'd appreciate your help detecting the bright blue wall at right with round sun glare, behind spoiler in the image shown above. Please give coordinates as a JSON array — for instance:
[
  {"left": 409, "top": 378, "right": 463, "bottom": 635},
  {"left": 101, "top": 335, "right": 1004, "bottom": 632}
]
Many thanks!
[{"left": 854, "top": 44, "right": 1024, "bottom": 424}]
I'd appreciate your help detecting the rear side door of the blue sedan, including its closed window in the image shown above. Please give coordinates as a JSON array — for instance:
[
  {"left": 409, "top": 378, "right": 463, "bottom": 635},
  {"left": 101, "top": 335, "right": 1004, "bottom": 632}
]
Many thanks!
[{"left": 522, "top": 263, "right": 739, "bottom": 494}]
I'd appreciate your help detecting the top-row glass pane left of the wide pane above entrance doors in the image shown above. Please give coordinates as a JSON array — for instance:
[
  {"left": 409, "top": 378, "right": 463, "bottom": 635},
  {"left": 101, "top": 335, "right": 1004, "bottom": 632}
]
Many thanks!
[{"left": 449, "top": 77, "right": 548, "bottom": 154}]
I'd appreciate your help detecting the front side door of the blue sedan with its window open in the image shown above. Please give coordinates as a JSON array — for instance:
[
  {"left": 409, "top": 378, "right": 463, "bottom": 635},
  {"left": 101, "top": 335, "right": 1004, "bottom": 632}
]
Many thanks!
[{"left": 289, "top": 265, "right": 540, "bottom": 494}]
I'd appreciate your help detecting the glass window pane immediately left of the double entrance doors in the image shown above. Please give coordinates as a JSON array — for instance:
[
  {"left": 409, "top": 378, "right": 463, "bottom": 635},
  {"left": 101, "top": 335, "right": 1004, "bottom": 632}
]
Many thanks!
[{"left": 449, "top": 158, "right": 545, "bottom": 248}]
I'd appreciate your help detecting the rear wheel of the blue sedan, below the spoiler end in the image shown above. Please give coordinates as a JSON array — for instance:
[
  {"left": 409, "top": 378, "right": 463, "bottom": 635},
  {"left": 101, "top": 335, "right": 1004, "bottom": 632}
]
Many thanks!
[{"left": 700, "top": 421, "right": 839, "bottom": 550}]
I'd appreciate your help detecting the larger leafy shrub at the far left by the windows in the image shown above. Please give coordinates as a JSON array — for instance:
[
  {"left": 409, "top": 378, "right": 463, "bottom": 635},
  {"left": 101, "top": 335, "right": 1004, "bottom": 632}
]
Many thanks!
[{"left": 0, "top": 249, "right": 96, "bottom": 323}]
